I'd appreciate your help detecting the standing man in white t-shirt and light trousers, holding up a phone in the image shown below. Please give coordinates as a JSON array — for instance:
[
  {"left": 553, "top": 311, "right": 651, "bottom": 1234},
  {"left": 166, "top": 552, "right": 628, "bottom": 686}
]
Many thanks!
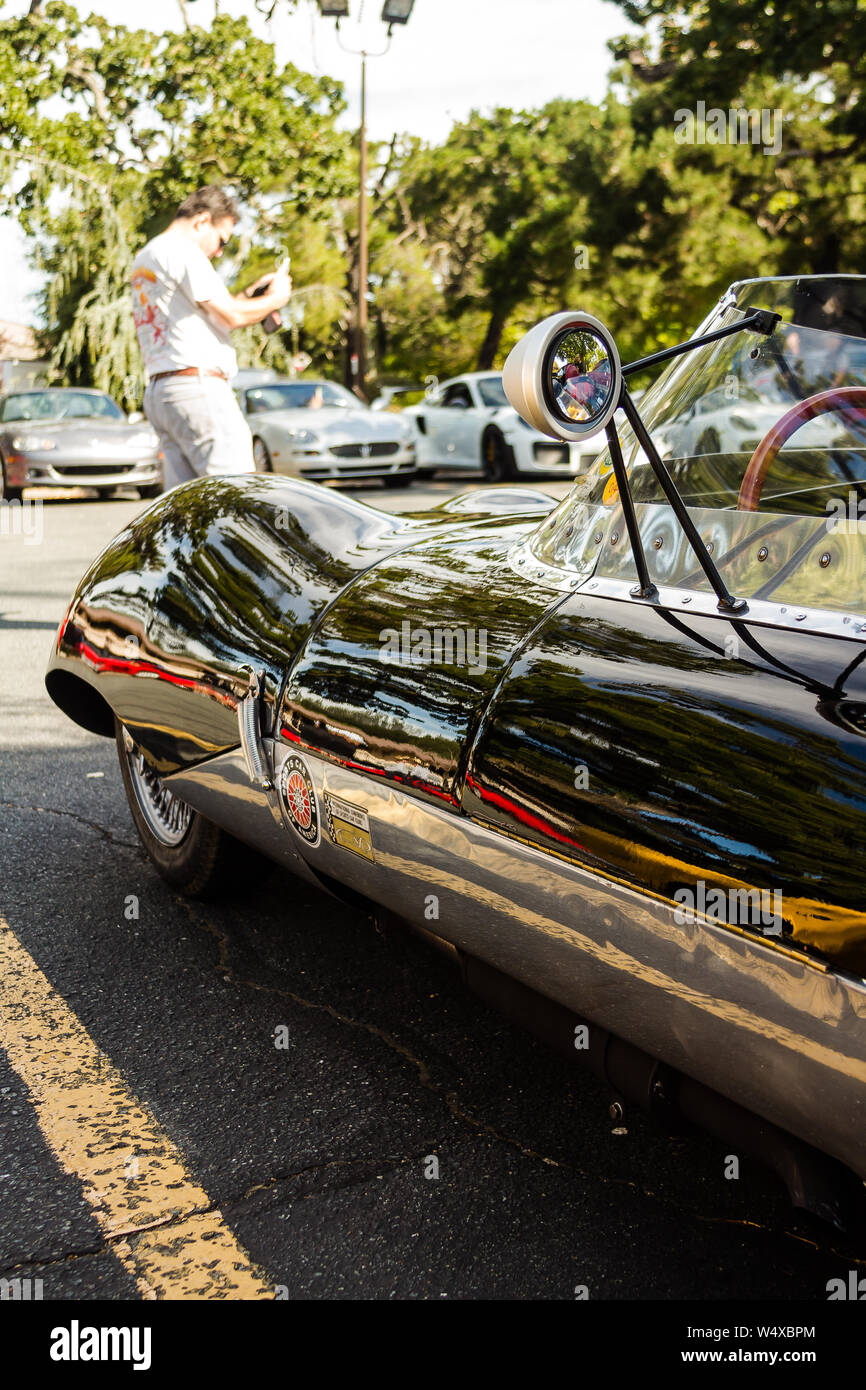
[{"left": 129, "top": 185, "right": 292, "bottom": 488}]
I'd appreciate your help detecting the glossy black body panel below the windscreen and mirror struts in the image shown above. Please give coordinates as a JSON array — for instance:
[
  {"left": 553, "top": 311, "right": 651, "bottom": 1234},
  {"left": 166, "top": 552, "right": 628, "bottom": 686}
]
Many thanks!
[{"left": 463, "top": 595, "right": 866, "bottom": 970}]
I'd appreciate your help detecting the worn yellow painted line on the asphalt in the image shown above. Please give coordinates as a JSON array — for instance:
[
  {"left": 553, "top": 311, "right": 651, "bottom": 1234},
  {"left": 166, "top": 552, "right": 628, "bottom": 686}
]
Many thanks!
[{"left": 0, "top": 916, "right": 274, "bottom": 1298}]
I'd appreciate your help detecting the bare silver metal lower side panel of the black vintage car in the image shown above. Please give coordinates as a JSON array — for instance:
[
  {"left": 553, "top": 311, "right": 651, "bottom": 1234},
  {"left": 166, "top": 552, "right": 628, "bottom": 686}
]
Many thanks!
[{"left": 171, "top": 742, "right": 866, "bottom": 1179}]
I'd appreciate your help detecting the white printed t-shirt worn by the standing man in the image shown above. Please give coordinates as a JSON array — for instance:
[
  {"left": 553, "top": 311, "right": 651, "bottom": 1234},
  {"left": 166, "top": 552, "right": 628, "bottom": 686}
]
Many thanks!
[{"left": 129, "top": 229, "right": 238, "bottom": 379}]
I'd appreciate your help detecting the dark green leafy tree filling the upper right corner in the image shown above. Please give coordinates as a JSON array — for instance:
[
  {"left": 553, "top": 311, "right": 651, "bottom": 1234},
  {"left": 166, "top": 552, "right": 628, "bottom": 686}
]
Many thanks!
[{"left": 610, "top": 0, "right": 866, "bottom": 274}]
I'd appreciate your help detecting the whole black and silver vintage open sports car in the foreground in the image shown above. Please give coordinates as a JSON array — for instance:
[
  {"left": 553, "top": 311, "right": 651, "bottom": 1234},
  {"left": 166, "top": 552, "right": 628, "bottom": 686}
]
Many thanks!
[{"left": 46, "top": 277, "right": 866, "bottom": 1222}]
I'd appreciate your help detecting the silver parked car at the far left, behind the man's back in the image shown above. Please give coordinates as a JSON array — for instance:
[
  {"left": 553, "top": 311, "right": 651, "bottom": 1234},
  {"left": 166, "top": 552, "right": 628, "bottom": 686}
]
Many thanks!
[{"left": 0, "top": 386, "right": 163, "bottom": 500}]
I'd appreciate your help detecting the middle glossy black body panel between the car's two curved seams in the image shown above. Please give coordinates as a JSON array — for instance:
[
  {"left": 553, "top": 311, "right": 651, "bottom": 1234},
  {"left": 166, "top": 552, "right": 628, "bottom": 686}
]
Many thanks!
[{"left": 279, "top": 518, "right": 562, "bottom": 806}]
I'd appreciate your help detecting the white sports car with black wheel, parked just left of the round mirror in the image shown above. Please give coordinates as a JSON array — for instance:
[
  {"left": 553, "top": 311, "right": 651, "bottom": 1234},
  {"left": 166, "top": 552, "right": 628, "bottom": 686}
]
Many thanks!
[{"left": 403, "top": 371, "right": 606, "bottom": 482}]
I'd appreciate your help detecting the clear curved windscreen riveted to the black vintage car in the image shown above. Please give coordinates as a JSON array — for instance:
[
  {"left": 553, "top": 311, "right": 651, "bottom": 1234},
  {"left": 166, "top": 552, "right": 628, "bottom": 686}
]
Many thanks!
[{"left": 532, "top": 281, "right": 866, "bottom": 610}]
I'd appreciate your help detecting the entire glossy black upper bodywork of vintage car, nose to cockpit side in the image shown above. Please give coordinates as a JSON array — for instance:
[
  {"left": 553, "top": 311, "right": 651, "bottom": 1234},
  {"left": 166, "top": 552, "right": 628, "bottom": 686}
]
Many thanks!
[{"left": 47, "top": 478, "right": 866, "bottom": 970}]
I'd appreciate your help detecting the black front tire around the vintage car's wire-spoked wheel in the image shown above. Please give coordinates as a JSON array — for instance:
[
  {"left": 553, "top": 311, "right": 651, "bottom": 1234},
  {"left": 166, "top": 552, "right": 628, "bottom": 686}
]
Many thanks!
[{"left": 114, "top": 719, "right": 274, "bottom": 898}]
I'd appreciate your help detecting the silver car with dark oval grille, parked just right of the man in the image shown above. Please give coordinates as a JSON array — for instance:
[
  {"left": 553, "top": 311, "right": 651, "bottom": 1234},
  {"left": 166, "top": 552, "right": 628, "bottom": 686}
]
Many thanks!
[{"left": 236, "top": 379, "right": 417, "bottom": 488}]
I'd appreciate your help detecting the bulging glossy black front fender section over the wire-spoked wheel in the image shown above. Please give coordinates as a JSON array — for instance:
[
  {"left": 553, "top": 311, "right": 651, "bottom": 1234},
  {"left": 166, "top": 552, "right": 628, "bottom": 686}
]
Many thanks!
[{"left": 46, "top": 477, "right": 552, "bottom": 774}]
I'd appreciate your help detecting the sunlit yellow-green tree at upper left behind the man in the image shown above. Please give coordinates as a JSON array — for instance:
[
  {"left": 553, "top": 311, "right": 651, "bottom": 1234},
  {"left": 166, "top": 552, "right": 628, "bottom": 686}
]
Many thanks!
[{"left": 0, "top": 0, "right": 349, "bottom": 403}]
